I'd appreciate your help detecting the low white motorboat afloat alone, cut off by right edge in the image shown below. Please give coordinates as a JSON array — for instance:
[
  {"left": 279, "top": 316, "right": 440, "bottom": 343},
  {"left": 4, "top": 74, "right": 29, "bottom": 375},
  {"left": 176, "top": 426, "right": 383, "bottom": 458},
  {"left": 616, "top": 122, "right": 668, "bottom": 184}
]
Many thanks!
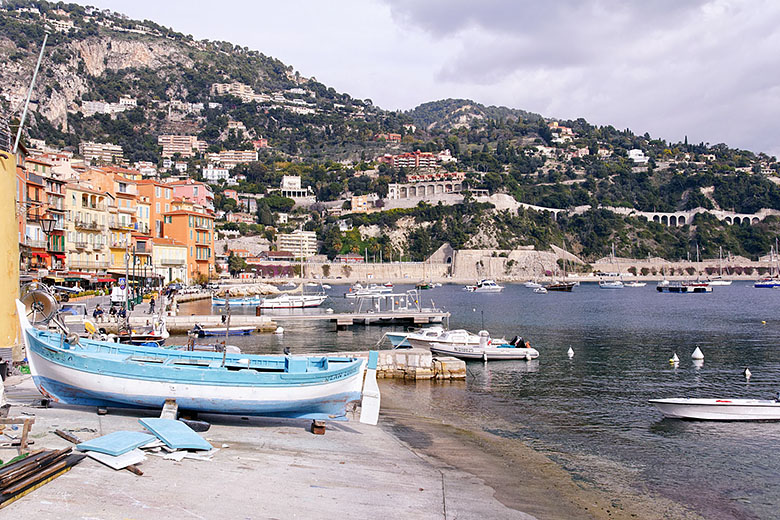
[{"left": 650, "top": 398, "right": 780, "bottom": 421}]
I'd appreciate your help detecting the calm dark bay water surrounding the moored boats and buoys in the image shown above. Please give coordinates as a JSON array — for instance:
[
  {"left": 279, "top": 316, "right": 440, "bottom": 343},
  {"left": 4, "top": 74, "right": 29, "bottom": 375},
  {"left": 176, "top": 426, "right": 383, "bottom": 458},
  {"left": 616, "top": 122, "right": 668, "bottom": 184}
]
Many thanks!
[{"left": 182, "top": 282, "right": 780, "bottom": 518}]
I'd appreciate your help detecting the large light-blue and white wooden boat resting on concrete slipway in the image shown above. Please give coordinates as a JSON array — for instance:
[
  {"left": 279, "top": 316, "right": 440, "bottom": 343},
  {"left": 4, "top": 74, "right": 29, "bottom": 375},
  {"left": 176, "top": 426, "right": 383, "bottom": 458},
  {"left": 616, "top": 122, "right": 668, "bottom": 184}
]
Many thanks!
[{"left": 17, "top": 302, "right": 366, "bottom": 420}]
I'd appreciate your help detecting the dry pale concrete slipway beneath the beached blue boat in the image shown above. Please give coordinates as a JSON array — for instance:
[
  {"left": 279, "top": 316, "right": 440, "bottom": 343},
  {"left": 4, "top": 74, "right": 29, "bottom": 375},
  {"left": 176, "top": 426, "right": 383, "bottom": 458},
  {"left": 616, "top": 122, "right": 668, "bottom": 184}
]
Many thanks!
[{"left": 0, "top": 376, "right": 533, "bottom": 520}]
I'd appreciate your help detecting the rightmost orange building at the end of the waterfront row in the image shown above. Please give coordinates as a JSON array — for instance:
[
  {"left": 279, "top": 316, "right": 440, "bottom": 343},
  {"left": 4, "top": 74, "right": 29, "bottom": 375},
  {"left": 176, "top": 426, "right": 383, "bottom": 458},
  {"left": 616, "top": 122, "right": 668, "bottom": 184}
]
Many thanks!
[{"left": 163, "top": 209, "right": 214, "bottom": 280}]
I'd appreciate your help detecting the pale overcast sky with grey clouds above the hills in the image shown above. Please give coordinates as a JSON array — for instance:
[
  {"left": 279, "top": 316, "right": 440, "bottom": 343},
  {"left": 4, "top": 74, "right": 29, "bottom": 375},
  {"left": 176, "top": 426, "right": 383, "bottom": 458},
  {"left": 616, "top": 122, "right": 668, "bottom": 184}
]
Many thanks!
[{"left": 80, "top": 0, "right": 780, "bottom": 155}]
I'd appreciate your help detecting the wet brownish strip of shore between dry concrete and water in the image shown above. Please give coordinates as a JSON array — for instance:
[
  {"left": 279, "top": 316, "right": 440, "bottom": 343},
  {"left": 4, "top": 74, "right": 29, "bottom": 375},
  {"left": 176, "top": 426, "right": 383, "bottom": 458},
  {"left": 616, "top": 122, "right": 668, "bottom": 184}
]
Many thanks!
[{"left": 380, "top": 383, "right": 704, "bottom": 520}]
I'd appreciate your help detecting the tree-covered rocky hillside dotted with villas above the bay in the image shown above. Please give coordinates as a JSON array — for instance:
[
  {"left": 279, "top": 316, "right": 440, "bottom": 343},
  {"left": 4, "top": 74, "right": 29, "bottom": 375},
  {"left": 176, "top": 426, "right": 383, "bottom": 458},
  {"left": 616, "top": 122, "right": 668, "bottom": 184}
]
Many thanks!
[{"left": 0, "top": 1, "right": 780, "bottom": 259}]
